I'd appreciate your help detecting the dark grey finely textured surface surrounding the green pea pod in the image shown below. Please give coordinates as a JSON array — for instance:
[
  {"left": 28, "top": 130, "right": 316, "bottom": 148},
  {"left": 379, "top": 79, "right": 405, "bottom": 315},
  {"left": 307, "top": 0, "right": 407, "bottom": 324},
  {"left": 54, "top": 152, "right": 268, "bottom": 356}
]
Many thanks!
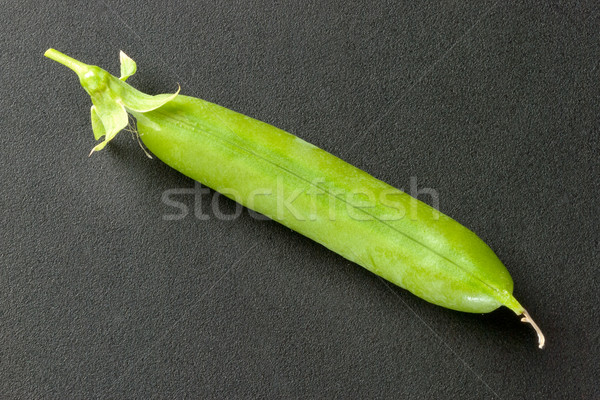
[{"left": 0, "top": 0, "right": 600, "bottom": 399}]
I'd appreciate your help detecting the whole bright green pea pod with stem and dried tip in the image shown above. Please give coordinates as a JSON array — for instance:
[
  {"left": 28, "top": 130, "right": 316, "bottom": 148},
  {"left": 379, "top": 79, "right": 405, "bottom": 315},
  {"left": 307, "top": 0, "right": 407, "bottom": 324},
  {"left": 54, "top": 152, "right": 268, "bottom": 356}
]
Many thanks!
[{"left": 45, "top": 49, "right": 544, "bottom": 348}]
